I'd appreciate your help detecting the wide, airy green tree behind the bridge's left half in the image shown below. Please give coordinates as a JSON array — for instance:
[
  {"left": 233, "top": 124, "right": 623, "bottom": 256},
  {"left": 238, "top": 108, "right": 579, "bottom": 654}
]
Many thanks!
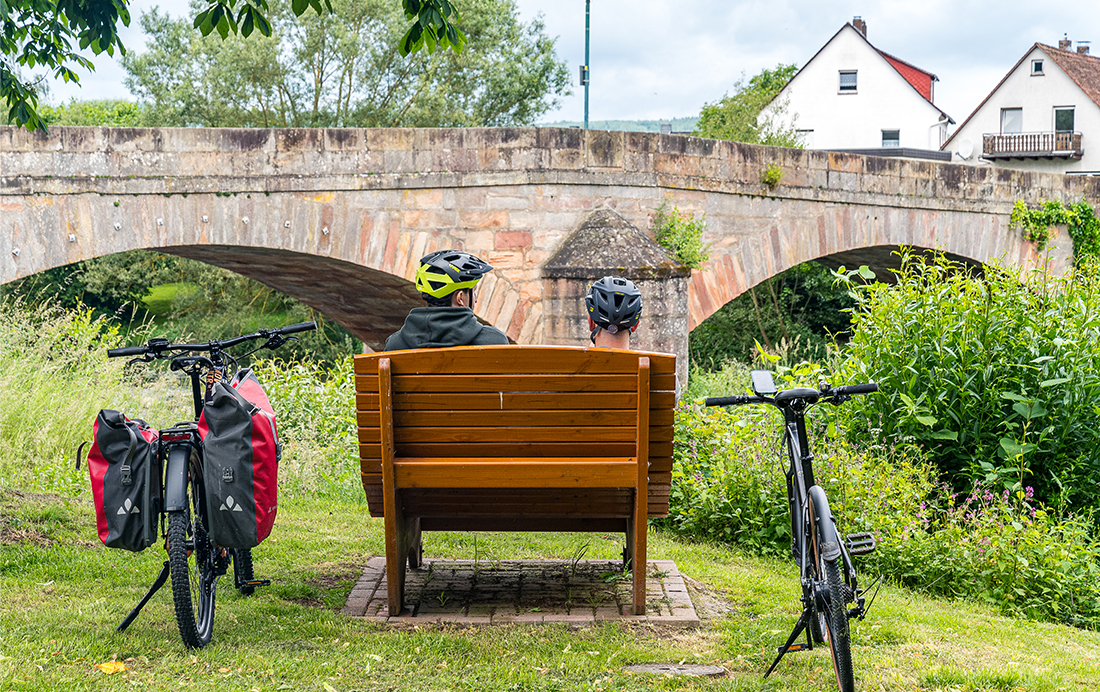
[{"left": 122, "top": 0, "right": 570, "bottom": 127}]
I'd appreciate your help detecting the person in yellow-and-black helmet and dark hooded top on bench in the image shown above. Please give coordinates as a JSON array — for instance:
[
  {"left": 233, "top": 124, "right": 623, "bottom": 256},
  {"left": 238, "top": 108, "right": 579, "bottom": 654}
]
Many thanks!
[{"left": 383, "top": 250, "right": 508, "bottom": 351}]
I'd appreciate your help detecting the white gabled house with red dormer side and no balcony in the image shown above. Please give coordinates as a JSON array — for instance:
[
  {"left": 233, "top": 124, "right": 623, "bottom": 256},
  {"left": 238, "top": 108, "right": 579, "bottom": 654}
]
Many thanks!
[{"left": 761, "top": 17, "right": 955, "bottom": 160}]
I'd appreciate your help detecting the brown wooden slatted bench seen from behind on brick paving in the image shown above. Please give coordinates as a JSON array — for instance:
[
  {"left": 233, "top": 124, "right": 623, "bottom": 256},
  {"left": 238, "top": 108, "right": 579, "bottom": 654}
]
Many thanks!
[{"left": 355, "top": 345, "right": 675, "bottom": 615}]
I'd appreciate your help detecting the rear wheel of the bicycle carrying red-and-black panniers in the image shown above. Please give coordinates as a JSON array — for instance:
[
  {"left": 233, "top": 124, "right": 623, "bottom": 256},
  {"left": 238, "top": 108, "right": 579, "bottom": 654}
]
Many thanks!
[{"left": 168, "top": 499, "right": 218, "bottom": 649}]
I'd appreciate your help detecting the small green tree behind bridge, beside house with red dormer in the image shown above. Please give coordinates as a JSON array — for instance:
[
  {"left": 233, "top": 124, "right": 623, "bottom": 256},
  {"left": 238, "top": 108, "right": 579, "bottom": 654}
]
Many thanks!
[{"left": 693, "top": 65, "right": 802, "bottom": 147}]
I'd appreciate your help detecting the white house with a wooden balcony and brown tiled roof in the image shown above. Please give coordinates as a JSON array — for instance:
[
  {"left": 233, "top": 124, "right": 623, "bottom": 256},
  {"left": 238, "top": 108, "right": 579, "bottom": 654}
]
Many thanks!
[{"left": 943, "top": 40, "right": 1100, "bottom": 175}]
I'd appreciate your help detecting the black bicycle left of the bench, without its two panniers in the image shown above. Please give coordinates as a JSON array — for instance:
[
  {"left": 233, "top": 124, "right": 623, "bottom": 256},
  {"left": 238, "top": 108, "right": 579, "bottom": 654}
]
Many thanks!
[{"left": 107, "top": 322, "right": 317, "bottom": 648}]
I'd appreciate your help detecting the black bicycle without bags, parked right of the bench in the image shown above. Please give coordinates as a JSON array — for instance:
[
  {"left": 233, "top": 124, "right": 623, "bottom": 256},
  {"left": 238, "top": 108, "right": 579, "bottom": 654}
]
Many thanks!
[{"left": 705, "top": 371, "right": 879, "bottom": 692}]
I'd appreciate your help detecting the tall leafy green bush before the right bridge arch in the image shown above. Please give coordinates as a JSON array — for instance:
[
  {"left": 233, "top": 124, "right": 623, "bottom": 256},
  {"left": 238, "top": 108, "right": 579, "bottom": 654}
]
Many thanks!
[{"left": 838, "top": 250, "right": 1100, "bottom": 510}]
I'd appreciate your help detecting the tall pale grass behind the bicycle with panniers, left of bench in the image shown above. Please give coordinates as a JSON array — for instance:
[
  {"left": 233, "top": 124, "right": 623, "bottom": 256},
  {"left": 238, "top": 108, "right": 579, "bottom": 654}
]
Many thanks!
[{"left": 0, "top": 301, "right": 363, "bottom": 502}]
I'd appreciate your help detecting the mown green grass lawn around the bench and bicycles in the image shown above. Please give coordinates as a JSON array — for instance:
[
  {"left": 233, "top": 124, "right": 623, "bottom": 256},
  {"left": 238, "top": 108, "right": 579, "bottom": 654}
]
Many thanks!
[{"left": 0, "top": 488, "right": 1100, "bottom": 692}]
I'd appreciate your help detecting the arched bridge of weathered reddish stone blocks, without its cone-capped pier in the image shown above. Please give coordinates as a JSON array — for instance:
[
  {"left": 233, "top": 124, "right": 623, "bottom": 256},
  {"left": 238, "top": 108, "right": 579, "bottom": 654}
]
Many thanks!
[{"left": 0, "top": 127, "right": 1086, "bottom": 371}]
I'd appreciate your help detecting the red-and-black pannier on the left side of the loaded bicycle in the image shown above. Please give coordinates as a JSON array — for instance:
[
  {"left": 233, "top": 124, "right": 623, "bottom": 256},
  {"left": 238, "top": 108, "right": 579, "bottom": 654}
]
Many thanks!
[{"left": 85, "top": 408, "right": 161, "bottom": 552}]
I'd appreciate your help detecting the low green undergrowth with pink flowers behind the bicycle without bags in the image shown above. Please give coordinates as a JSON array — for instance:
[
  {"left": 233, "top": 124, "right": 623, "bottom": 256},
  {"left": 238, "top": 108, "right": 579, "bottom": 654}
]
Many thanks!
[{"left": 659, "top": 363, "right": 1100, "bottom": 627}]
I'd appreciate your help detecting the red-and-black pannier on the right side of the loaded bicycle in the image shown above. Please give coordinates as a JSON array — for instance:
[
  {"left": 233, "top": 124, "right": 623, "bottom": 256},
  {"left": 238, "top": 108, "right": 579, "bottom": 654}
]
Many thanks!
[{"left": 199, "top": 367, "right": 283, "bottom": 548}]
